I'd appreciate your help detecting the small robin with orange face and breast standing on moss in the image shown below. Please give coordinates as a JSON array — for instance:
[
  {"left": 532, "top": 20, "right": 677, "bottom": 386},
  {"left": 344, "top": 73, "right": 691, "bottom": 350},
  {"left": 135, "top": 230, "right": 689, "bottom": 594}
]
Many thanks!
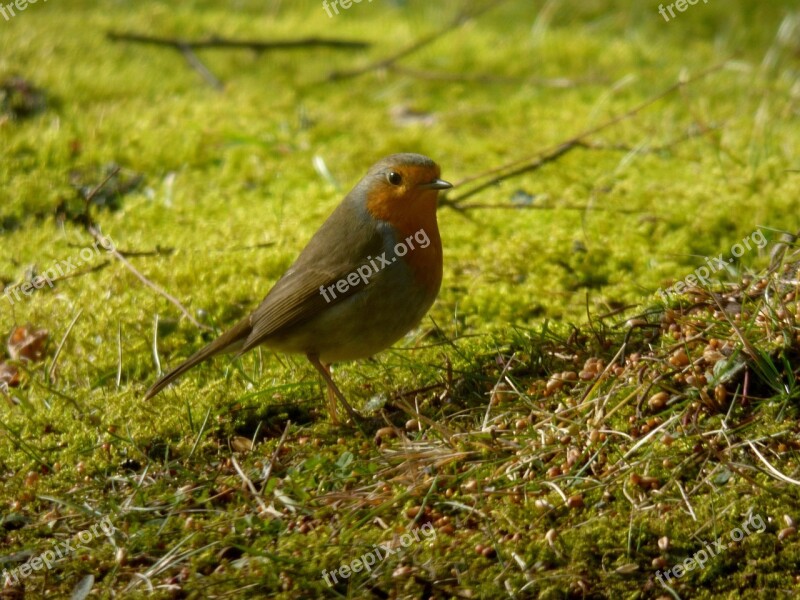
[{"left": 145, "top": 153, "right": 453, "bottom": 424}]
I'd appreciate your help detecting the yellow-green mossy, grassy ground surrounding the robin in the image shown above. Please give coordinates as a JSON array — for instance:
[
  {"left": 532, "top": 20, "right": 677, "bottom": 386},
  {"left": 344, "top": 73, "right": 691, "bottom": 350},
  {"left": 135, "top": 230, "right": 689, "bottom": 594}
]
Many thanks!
[{"left": 0, "top": 0, "right": 800, "bottom": 598}]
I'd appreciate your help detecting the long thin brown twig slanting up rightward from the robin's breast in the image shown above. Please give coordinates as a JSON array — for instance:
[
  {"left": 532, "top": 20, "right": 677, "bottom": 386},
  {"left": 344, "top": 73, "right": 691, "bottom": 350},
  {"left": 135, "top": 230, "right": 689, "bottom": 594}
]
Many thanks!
[{"left": 440, "top": 62, "right": 725, "bottom": 210}]
